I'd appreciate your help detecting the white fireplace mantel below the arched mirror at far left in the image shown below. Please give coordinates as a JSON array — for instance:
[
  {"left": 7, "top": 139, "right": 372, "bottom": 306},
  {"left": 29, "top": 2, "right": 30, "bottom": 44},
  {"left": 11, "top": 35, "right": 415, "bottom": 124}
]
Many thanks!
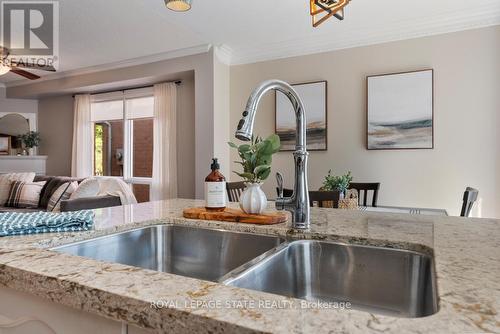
[{"left": 0, "top": 155, "right": 47, "bottom": 175}]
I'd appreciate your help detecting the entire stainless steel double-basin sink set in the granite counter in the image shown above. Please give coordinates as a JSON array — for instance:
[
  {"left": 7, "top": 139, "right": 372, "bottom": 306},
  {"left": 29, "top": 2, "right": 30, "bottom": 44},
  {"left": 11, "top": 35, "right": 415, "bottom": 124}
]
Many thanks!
[{"left": 53, "top": 225, "right": 438, "bottom": 317}]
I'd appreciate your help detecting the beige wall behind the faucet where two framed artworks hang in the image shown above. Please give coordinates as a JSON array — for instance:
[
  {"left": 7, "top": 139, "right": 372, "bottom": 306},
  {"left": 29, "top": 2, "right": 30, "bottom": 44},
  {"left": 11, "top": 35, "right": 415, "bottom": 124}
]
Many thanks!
[{"left": 230, "top": 26, "right": 500, "bottom": 217}]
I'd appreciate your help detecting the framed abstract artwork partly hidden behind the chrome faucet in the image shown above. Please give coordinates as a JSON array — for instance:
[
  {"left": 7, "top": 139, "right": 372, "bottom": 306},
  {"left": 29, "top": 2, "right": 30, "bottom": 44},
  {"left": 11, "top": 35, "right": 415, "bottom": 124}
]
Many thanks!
[{"left": 275, "top": 81, "right": 328, "bottom": 151}]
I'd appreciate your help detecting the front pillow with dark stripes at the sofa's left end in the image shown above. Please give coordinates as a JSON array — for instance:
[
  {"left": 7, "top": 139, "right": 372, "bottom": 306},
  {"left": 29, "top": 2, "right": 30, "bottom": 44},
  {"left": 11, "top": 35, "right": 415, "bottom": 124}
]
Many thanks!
[{"left": 5, "top": 181, "right": 45, "bottom": 209}]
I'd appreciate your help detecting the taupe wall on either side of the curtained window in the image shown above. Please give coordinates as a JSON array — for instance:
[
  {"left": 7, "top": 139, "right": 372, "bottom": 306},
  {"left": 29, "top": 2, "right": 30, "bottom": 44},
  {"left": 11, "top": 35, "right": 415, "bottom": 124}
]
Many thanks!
[{"left": 38, "top": 76, "right": 195, "bottom": 198}]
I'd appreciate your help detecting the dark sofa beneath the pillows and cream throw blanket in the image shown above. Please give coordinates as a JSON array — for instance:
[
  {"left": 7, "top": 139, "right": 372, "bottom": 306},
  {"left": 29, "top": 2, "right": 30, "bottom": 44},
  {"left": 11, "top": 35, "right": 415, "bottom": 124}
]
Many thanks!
[{"left": 0, "top": 175, "right": 122, "bottom": 212}]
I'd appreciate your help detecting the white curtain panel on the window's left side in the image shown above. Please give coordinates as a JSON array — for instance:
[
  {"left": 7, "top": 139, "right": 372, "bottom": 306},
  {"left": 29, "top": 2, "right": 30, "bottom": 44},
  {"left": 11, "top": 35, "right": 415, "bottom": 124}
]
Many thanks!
[{"left": 71, "top": 94, "right": 94, "bottom": 178}]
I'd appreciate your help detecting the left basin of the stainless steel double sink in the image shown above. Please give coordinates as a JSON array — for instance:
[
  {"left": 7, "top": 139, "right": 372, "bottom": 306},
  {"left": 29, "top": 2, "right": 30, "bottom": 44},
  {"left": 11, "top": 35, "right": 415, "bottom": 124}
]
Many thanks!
[{"left": 54, "top": 225, "right": 283, "bottom": 282}]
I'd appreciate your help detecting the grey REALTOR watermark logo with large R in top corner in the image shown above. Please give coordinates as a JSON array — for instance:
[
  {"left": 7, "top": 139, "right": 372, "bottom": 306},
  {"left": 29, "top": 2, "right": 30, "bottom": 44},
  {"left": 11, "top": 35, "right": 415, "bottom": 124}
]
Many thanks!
[{"left": 0, "top": 0, "right": 59, "bottom": 66}]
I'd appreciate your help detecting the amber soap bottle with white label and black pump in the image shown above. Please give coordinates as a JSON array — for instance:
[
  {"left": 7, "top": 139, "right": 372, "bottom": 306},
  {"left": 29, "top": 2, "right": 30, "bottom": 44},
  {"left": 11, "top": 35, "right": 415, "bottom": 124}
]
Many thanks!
[{"left": 205, "top": 158, "right": 227, "bottom": 211}]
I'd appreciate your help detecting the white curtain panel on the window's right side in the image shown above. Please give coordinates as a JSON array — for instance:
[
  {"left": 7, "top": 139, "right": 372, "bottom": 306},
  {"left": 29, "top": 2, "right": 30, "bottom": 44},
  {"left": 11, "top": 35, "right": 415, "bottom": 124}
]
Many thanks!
[{"left": 150, "top": 83, "right": 177, "bottom": 201}]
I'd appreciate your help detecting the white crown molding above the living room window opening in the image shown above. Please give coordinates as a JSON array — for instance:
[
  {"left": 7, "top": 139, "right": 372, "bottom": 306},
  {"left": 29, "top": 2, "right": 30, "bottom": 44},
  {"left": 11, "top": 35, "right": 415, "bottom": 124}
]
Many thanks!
[{"left": 5, "top": 44, "right": 210, "bottom": 87}]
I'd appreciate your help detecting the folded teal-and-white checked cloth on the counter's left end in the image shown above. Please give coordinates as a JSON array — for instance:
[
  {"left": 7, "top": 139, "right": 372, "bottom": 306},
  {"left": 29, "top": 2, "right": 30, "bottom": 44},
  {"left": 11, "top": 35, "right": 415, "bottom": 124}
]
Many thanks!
[{"left": 0, "top": 210, "right": 94, "bottom": 237}]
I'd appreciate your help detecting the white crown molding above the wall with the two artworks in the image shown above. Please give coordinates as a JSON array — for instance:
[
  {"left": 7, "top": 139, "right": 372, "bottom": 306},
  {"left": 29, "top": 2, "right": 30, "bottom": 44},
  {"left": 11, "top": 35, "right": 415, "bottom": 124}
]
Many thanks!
[{"left": 231, "top": 4, "right": 500, "bottom": 65}]
